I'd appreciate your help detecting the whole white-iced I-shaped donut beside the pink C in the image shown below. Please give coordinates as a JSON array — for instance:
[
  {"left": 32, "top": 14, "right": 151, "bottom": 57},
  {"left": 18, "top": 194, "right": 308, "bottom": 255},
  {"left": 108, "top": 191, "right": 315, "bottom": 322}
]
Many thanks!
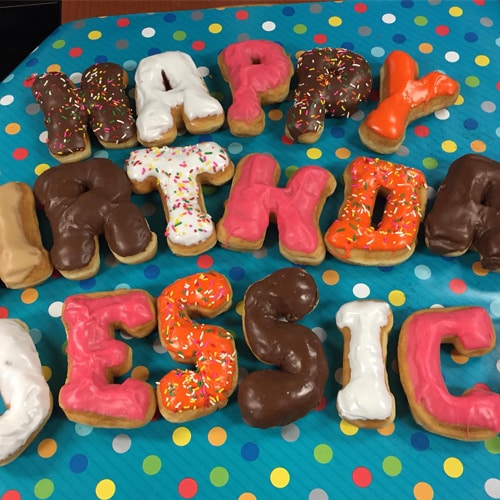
[{"left": 335, "top": 300, "right": 396, "bottom": 429}]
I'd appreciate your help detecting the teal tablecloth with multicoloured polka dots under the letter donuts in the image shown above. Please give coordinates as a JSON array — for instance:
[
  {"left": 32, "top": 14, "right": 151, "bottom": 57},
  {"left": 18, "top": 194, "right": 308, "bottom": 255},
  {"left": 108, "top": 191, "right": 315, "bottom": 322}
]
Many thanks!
[{"left": 0, "top": 0, "right": 500, "bottom": 500}]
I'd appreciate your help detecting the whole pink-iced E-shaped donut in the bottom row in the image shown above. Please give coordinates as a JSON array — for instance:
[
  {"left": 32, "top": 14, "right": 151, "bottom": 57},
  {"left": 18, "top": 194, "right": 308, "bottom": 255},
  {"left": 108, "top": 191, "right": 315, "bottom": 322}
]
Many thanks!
[{"left": 59, "top": 289, "right": 157, "bottom": 428}]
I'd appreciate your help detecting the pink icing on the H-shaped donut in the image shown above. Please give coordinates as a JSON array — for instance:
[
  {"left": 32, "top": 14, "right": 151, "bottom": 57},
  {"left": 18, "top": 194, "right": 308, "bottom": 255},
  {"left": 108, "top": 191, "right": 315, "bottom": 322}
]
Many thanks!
[{"left": 218, "top": 153, "right": 331, "bottom": 253}]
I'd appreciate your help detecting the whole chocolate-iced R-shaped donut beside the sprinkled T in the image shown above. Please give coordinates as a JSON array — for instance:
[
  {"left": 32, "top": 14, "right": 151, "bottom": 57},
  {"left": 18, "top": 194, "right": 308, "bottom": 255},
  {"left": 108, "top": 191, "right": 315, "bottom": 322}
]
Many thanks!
[{"left": 34, "top": 158, "right": 157, "bottom": 280}]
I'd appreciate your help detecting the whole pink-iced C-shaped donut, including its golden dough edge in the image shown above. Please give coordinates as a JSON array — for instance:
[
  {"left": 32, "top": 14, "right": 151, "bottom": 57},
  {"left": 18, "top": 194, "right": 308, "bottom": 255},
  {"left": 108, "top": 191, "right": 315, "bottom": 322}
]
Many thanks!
[{"left": 398, "top": 306, "right": 500, "bottom": 441}]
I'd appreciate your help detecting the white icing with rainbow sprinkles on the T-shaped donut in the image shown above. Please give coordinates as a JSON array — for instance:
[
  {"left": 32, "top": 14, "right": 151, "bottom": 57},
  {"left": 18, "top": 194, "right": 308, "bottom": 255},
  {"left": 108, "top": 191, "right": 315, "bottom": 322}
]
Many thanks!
[{"left": 125, "top": 142, "right": 231, "bottom": 246}]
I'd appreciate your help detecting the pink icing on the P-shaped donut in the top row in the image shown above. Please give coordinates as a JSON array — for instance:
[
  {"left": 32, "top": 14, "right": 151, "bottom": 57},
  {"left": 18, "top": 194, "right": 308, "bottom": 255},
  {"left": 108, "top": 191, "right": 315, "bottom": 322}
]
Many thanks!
[{"left": 222, "top": 40, "right": 291, "bottom": 122}]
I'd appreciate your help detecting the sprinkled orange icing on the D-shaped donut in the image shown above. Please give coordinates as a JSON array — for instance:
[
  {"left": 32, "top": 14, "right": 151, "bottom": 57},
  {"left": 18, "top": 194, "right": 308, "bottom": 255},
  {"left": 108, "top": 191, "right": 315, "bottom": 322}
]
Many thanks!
[{"left": 325, "top": 157, "right": 427, "bottom": 256}]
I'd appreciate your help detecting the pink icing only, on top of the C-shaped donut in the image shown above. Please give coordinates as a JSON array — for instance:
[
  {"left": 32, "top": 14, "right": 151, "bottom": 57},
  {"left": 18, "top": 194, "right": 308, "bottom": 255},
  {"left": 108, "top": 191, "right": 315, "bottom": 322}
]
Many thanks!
[{"left": 404, "top": 307, "right": 500, "bottom": 434}]
